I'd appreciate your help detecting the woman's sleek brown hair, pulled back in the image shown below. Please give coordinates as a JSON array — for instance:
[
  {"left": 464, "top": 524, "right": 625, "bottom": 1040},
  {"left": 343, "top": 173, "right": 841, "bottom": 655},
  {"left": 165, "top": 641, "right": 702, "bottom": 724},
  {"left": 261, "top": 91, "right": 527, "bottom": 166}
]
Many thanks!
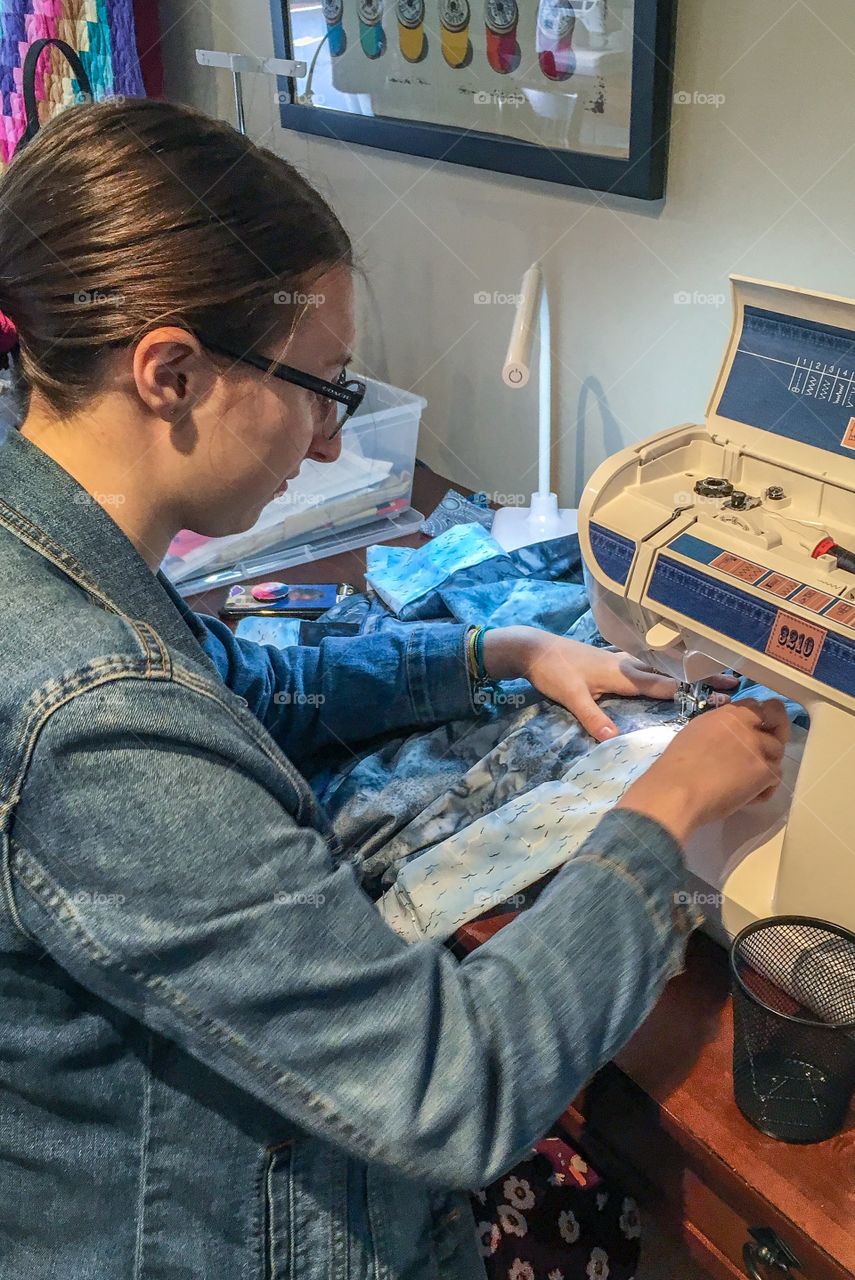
[{"left": 0, "top": 99, "right": 353, "bottom": 416}]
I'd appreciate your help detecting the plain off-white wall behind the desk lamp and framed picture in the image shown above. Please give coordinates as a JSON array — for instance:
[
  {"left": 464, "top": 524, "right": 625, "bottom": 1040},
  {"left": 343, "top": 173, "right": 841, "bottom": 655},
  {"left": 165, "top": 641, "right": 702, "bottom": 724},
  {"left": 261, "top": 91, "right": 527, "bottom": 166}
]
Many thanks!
[{"left": 160, "top": 0, "right": 855, "bottom": 503}]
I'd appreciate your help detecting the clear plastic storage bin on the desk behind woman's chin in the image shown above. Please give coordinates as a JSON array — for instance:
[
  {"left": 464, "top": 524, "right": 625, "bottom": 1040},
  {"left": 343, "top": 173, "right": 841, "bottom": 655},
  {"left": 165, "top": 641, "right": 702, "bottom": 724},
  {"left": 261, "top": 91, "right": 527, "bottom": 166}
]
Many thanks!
[{"left": 161, "top": 378, "right": 428, "bottom": 595}]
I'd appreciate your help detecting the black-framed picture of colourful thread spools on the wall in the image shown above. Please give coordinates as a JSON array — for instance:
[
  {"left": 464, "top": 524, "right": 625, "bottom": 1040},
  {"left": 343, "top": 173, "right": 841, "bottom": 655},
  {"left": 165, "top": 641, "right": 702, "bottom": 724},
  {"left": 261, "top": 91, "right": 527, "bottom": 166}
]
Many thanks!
[{"left": 271, "top": 0, "right": 676, "bottom": 200}]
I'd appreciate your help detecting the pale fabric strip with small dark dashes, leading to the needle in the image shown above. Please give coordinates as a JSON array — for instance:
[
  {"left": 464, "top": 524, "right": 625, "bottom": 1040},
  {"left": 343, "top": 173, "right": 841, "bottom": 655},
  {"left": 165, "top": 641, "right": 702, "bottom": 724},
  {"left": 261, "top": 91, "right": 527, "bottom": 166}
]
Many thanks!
[{"left": 378, "top": 722, "right": 680, "bottom": 942}]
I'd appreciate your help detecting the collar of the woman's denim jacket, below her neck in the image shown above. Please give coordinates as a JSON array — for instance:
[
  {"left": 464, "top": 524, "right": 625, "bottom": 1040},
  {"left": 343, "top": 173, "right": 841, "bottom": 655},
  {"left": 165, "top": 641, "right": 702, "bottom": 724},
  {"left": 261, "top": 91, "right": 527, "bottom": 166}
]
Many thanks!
[{"left": 0, "top": 428, "right": 223, "bottom": 673}]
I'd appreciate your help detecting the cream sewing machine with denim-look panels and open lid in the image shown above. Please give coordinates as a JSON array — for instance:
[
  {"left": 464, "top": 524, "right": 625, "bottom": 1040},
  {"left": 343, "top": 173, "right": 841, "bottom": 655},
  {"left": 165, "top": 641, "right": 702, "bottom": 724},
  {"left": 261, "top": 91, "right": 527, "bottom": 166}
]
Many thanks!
[{"left": 579, "top": 276, "right": 855, "bottom": 936}]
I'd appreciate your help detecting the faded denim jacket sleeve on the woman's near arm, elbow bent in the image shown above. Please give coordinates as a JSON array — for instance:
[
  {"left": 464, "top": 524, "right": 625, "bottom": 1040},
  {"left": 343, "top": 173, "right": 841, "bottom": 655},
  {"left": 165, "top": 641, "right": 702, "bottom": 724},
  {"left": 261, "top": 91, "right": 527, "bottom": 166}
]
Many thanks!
[{"left": 9, "top": 678, "right": 696, "bottom": 1188}]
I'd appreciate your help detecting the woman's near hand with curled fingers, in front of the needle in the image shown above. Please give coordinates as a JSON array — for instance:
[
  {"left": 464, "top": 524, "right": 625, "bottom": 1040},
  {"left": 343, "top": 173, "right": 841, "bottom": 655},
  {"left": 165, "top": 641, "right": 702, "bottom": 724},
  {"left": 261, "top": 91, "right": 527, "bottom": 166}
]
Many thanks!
[{"left": 616, "top": 698, "right": 790, "bottom": 844}]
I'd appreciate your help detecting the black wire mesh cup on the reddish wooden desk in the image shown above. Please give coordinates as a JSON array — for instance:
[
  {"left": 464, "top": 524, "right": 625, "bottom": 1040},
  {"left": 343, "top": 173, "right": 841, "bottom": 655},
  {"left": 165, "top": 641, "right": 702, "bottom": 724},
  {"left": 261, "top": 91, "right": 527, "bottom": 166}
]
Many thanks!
[{"left": 731, "top": 915, "right": 855, "bottom": 1142}]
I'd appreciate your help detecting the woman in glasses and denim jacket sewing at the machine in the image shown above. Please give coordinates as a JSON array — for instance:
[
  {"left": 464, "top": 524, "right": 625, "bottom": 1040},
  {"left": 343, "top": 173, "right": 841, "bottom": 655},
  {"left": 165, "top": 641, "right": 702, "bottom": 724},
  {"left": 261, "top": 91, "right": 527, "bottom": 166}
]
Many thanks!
[{"left": 0, "top": 101, "right": 786, "bottom": 1280}]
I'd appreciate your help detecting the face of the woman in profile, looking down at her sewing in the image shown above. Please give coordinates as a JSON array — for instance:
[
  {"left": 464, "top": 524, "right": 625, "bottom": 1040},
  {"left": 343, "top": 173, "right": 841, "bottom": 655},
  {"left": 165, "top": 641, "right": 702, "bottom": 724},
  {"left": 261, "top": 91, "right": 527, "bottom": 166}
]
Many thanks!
[{"left": 175, "top": 266, "right": 353, "bottom": 536}]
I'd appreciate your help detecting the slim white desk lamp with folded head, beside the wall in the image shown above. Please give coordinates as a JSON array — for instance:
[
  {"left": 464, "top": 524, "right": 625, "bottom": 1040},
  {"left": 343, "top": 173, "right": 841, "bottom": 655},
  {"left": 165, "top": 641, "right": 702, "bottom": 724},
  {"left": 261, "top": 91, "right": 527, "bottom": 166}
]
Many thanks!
[{"left": 490, "top": 262, "right": 577, "bottom": 552}]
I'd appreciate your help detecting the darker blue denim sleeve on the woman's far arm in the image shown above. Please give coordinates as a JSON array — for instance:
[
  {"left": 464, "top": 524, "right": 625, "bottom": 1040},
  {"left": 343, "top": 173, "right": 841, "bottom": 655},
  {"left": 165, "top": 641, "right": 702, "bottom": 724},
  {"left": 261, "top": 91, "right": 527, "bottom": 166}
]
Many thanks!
[{"left": 195, "top": 613, "right": 477, "bottom": 759}]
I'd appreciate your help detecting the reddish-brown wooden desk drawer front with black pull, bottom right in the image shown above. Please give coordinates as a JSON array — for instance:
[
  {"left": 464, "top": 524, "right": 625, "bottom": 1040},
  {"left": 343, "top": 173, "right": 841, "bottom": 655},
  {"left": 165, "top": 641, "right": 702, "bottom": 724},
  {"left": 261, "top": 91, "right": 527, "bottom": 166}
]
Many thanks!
[{"left": 564, "top": 1068, "right": 852, "bottom": 1280}]
